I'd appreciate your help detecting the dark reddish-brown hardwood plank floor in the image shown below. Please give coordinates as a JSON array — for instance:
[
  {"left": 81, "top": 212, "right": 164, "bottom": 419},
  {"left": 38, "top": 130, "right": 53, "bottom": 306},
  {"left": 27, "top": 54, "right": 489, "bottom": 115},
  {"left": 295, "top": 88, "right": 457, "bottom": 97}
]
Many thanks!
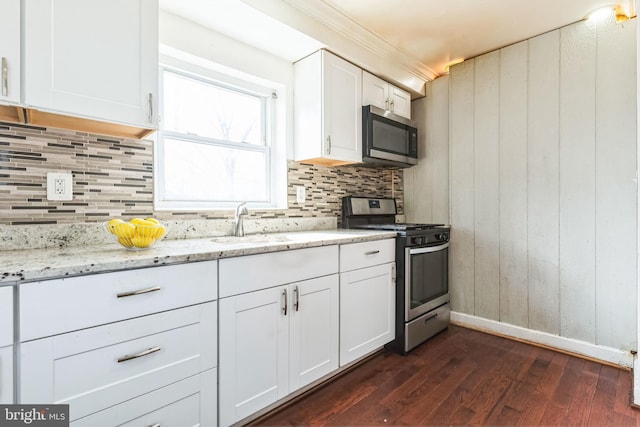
[{"left": 253, "top": 326, "right": 640, "bottom": 426}]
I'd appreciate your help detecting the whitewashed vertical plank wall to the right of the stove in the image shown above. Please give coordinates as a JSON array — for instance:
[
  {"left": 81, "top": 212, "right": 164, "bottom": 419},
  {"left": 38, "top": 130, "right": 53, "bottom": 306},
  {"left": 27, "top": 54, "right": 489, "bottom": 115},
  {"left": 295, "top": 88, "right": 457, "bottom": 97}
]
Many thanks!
[{"left": 440, "top": 15, "right": 637, "bottom": 350}]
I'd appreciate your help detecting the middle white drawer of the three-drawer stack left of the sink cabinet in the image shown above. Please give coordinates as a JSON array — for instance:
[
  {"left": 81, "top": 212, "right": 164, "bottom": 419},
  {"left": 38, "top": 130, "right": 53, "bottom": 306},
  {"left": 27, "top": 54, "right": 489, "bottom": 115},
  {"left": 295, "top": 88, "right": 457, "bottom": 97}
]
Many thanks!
[{"left": 20, "top": 302, "right": 217, "bottom": 421}]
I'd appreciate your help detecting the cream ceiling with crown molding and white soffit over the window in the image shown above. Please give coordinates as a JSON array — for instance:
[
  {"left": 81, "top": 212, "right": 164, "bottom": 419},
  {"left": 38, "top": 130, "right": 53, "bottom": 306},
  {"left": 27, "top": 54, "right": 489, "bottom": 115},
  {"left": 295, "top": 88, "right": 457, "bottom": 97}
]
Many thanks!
[{"left": 160, "top": 0, "right": 635, "bottom": 95}]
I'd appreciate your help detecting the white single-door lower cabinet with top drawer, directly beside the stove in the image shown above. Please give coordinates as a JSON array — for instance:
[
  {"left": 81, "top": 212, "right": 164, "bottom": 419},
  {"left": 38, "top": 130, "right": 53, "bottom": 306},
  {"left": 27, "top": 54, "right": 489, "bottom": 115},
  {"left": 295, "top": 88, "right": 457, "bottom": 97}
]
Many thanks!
[{"left": 340, "top": 240, "right": 396, "bottom": 366}]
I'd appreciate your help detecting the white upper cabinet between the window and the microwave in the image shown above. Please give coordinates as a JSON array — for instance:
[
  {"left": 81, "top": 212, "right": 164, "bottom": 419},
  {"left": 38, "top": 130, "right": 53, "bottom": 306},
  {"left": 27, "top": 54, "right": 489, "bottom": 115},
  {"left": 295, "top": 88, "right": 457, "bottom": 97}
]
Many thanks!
[{"left": 294, "top": 50, "right": 362, "bottom": 166}]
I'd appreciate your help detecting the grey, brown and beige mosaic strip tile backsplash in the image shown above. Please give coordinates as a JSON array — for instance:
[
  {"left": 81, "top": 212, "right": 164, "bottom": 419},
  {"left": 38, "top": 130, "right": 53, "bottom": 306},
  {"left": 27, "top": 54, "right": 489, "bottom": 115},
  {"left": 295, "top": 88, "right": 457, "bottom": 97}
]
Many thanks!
[{"left": 0, "top": 122, "right": 403, "bottom": 225}]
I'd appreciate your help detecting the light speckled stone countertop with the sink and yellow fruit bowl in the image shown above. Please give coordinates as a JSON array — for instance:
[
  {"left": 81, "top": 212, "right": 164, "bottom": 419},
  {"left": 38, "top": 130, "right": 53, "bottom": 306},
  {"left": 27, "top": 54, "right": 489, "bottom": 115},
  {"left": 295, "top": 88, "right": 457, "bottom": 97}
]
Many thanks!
[{"left": 0, "top": 229, "right": 396, "bottom": 286}]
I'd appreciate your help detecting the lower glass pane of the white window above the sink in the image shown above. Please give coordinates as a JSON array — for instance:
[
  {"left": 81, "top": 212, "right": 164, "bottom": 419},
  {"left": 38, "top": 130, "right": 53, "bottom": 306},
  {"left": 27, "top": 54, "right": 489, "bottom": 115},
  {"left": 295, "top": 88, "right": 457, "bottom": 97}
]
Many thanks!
[{"left": 164, "top": 138, "right": 269, "bottom": 202}]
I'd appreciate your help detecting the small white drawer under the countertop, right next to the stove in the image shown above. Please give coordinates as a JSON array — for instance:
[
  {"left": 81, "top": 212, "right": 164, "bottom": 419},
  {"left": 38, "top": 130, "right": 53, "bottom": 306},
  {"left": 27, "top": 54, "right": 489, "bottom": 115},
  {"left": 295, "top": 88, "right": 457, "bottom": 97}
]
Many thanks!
[{"left": 340, "top": 239, "right": 396, "bottom": 271}]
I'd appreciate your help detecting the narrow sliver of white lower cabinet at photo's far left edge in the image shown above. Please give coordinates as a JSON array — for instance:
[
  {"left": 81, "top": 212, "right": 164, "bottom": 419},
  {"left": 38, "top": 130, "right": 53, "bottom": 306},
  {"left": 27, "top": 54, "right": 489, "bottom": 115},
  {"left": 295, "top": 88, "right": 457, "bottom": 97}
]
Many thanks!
[{"left": 0, "top": 286, "right": 13, "bottom": 404}]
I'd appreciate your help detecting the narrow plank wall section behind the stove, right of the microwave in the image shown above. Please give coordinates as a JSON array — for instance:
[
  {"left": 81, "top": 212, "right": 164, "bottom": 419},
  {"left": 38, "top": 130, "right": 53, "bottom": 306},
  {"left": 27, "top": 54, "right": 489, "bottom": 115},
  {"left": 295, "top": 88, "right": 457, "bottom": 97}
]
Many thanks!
[{"left": 403, "top": 76, "right": 449, "bottom": 224}]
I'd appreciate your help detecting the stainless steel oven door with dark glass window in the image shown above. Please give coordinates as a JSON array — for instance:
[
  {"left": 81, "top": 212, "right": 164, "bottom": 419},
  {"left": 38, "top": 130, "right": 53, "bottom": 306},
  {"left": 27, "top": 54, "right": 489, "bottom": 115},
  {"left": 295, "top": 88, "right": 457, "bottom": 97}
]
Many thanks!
[{"left": 409, "top": 244, "right": 449, "bottom": 310}]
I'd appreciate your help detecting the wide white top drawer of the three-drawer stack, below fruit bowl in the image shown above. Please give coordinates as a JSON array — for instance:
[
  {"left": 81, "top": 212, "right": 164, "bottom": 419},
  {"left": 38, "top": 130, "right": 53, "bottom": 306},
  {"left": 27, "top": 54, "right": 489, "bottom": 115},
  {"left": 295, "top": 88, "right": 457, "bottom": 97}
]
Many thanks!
[{"left": 20, "top": 261, "right": 217, "bottom": 342}]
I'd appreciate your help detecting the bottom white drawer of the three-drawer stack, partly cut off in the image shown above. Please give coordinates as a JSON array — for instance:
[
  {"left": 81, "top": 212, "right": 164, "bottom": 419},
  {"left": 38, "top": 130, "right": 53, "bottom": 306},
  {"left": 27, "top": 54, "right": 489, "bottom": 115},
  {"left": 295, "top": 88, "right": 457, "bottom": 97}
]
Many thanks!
[{"left": 71, "top": 369, "right": 217, "bottom": 427}]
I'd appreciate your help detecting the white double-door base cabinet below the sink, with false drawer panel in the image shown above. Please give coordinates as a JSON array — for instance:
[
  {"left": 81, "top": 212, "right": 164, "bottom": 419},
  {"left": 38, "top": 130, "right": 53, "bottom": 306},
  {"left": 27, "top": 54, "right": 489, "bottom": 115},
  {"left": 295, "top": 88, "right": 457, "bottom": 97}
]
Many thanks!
[{"left": 219, "top": 246, "right": 339, "bottom": 426}]
